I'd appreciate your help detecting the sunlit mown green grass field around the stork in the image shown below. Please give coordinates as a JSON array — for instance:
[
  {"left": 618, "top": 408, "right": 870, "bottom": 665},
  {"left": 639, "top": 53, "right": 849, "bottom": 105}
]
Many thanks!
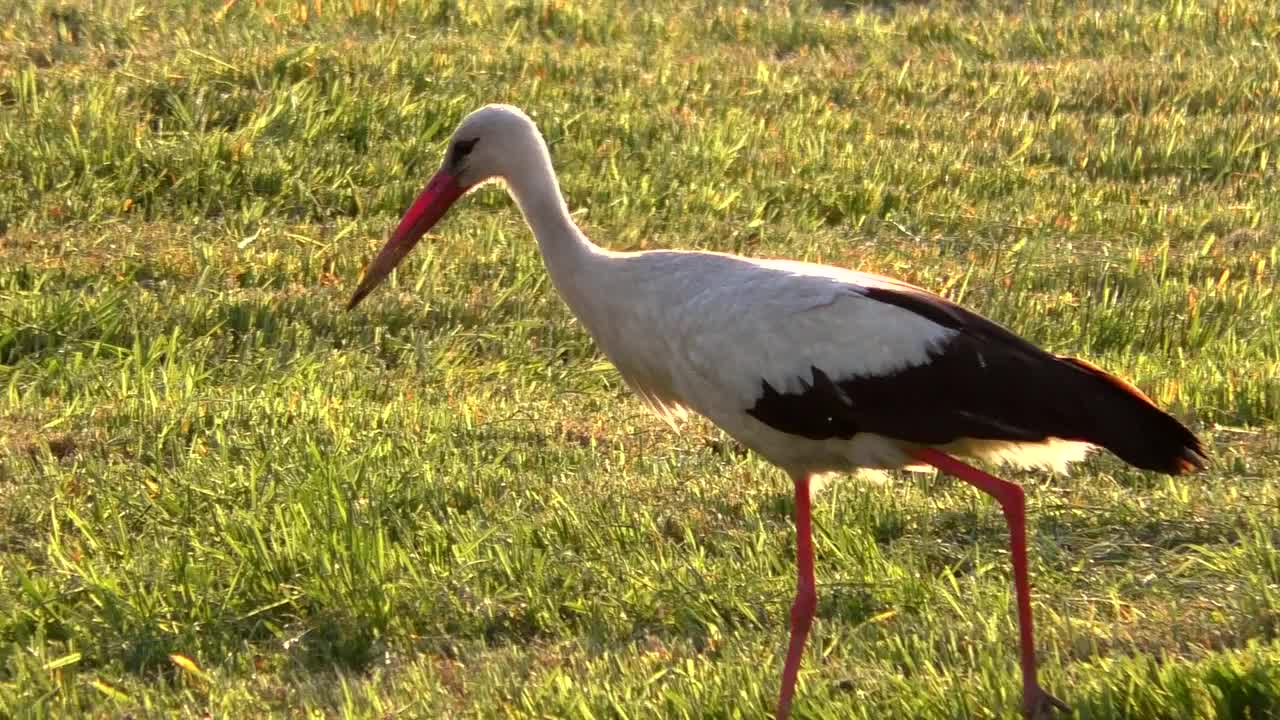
[{"left": 0, "top": 0, "right": 1280, "bottom": 719}]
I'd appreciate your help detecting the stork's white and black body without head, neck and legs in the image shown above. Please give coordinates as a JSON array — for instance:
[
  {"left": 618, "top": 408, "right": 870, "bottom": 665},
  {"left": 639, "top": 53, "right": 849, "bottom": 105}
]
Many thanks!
[{"left": 491, "top": 232, "right": 1196, "bottom": 473}]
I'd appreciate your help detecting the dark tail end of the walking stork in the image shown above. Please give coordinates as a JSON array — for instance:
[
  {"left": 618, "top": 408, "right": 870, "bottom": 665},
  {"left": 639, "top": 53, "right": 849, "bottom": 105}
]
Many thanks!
[{"left": 1057, "top": 356, "right": 1207, "bottom": 475}]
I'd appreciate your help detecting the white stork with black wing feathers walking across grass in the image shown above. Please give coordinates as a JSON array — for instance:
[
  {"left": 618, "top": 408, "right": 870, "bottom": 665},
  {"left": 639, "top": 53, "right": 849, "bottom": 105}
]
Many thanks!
[{"left": 347, "top": 104, "right": 1208, "bottom": 720}]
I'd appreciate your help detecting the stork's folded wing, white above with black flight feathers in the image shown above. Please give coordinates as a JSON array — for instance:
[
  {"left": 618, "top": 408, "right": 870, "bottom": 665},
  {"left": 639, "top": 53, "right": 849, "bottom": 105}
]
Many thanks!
[{"left": 670, "top": 254, "right": 1079, "bottom": 445}]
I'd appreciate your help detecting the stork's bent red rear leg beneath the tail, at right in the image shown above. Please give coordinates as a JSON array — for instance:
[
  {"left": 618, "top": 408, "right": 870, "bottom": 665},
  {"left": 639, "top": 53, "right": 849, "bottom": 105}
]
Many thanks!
[{"left": 911, "top": 448, "right": 1071, "bottom": 720}]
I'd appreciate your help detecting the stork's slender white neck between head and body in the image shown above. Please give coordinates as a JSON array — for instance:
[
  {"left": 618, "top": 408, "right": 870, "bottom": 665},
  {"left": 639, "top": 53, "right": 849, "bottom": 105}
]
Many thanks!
[{"left": 507, "top": 147, "right": 608, "bottom": 310}]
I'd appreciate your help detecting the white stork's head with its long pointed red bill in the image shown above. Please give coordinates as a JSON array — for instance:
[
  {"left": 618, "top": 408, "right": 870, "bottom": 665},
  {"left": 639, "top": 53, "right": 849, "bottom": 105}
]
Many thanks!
[{"left": 347, "top": 105, "right": 547, "bottom": 310}]
